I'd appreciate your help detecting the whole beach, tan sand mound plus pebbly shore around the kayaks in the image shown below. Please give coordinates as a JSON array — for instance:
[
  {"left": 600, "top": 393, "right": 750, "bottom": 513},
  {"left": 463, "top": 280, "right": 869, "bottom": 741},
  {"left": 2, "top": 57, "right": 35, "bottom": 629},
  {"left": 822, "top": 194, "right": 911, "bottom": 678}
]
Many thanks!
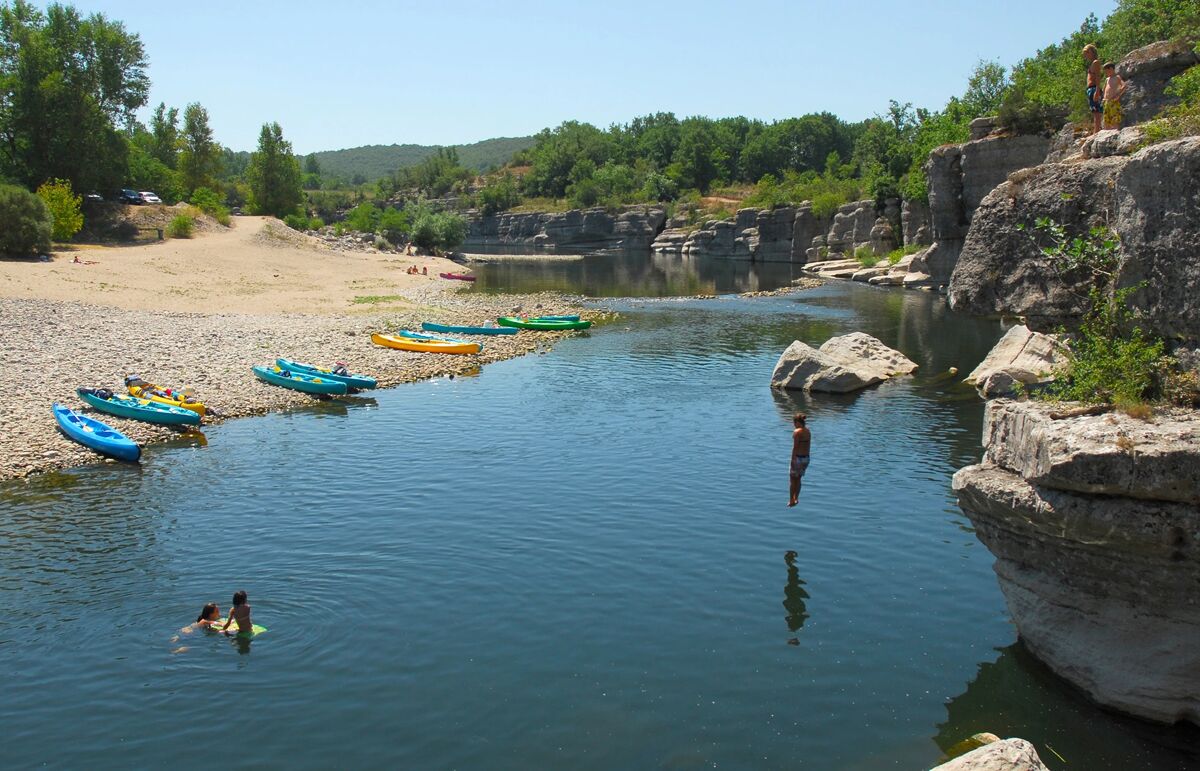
[{"left": 0, "top": 217, "right": 600, "bottom": 480}]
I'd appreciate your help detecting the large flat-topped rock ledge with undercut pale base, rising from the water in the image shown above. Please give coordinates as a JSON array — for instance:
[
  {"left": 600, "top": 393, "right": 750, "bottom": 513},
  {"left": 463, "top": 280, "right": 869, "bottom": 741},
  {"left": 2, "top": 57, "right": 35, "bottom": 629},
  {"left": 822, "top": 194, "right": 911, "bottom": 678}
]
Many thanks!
[{"left": 953, "top": 400, "right": 1200, "bottom": 724}]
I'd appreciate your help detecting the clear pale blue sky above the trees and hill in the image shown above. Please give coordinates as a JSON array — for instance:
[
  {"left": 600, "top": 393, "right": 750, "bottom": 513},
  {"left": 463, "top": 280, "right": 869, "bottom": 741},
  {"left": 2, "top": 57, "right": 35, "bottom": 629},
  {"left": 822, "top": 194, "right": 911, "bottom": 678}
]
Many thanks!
[{"left": 65, "top": 0, "right": 1115, "bottom": 153}]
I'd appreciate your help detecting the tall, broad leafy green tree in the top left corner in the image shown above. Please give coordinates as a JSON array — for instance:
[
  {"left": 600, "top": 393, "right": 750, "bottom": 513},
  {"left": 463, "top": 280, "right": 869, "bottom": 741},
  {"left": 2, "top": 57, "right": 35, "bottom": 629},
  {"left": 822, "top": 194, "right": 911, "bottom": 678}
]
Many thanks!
[{"left": 0, "top": 0, "right": 149, "bottom": 190}]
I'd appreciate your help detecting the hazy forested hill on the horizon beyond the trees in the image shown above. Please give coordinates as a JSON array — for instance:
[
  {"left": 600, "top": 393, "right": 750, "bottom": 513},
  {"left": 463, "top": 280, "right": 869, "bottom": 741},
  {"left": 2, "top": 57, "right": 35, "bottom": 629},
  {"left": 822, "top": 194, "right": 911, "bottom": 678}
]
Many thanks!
[{"left": 314, "top": 137, "right": 533, "bottom": 181}]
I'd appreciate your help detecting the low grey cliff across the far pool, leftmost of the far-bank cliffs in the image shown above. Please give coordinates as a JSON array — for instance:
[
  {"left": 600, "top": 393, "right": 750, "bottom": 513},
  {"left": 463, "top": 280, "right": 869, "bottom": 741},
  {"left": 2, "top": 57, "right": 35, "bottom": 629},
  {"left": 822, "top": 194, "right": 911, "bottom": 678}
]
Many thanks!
[{"left": 463, "top": 207, "right": 666, "bottom": 250}]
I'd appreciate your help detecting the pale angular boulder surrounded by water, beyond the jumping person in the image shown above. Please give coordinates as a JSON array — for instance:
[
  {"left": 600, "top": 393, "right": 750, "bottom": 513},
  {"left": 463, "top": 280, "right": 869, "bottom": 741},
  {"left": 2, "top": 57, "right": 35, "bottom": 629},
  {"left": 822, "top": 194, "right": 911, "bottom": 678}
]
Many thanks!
[{"left": 770, "top": 331, "right": 917, "bottom": 394}]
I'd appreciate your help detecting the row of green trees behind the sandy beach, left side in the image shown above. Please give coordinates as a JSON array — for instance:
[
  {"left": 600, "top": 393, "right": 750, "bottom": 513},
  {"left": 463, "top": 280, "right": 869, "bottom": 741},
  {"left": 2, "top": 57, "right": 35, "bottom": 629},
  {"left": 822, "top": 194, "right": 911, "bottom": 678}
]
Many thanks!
[{"left": 0, "top": 0, "right": 302, "bottom": 252}]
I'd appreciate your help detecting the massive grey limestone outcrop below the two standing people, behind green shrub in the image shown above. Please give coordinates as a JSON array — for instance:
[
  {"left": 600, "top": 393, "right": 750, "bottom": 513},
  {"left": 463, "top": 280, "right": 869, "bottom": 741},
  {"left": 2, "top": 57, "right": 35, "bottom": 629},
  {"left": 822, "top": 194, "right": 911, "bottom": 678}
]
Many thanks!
[{"left": 949, "top": 137, "right": 1200, "bottom": 343}]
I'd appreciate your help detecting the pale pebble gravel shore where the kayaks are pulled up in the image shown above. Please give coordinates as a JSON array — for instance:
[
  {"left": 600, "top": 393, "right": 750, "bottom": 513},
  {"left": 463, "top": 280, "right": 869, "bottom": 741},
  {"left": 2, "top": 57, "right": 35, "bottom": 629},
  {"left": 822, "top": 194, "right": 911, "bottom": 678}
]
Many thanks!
[{"left": 0, "top": 286, "right": 605, "bottom": 480}]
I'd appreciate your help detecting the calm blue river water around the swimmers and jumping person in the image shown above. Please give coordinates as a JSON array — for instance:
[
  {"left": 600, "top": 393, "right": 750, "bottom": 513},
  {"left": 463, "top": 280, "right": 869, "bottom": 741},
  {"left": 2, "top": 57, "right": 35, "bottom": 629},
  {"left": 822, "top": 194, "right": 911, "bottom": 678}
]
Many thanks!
[{"left": 0, "top": 258, "right": 1195, "bottom": 769}]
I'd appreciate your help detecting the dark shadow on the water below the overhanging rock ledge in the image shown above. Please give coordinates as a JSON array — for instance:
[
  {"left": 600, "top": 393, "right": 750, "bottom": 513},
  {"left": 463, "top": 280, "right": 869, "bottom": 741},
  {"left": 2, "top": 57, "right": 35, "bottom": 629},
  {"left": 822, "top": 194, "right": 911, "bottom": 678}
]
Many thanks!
[{"left": 934, "top": 643, "right": 1200, "bottom": 771}]
